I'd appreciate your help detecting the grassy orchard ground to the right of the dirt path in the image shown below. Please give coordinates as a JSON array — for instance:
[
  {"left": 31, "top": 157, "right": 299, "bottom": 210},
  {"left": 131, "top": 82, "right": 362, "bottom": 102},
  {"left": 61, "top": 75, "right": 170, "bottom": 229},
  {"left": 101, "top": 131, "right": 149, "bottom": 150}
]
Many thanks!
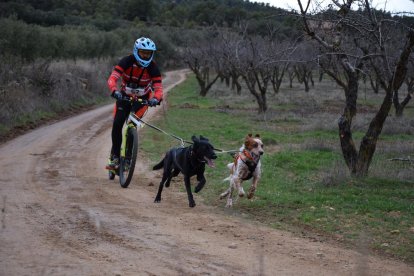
[{"left": 141, "top": 73, "right": 414, "bottom": 263}]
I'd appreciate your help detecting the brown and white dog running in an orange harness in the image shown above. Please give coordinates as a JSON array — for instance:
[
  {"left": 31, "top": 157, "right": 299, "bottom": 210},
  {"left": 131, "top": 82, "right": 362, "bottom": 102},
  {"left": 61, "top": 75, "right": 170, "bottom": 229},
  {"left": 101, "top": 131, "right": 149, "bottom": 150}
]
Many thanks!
[{"left": 220, "top": 134, "right": 264, "bottom": 207}]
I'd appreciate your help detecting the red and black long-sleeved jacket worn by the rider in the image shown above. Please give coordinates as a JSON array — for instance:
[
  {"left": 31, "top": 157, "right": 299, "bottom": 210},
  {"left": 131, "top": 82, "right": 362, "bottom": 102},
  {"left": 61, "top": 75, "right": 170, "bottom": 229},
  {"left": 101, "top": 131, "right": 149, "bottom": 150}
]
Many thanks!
[{"left": 108, "top": 55, "right": 163, "bottom": 101}]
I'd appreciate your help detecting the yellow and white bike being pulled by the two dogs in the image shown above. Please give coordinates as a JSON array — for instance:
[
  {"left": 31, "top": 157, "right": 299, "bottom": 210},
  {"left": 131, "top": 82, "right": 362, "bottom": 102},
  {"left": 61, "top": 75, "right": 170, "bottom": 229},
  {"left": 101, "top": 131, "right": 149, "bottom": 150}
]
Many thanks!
[{"left": 108, "top": 96, "right": 148, "bottom": 188}]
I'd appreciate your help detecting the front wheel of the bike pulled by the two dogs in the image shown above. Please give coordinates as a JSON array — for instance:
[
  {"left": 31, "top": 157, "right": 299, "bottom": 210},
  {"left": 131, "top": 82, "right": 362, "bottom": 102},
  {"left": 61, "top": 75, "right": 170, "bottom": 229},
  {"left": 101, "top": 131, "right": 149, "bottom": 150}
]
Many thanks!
[{"left": 119, "top": 128, "right": 138, "bottom": 188}]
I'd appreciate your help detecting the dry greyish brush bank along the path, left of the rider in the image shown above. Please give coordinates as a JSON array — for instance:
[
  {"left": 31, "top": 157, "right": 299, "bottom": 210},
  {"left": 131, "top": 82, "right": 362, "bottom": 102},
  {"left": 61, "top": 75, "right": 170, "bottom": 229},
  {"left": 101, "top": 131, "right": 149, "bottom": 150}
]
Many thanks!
[{"left": 0, "top": 60, "right": 112, "bottom": 136}]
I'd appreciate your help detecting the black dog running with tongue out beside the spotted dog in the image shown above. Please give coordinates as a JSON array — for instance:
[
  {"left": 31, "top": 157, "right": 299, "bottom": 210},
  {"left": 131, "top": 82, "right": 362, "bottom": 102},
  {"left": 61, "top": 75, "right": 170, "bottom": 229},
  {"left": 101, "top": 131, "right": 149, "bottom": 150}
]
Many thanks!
[{"left": 153, "top": 135, "right": 217, "bottom": 207}]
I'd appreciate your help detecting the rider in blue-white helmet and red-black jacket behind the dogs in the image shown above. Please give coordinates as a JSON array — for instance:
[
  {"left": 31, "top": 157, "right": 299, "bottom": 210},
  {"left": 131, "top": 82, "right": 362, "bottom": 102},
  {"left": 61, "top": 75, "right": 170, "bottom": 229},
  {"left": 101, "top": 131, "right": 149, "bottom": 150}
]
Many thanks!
[{"left": 106, "top": 37, "right": 163, "bottom": 170}]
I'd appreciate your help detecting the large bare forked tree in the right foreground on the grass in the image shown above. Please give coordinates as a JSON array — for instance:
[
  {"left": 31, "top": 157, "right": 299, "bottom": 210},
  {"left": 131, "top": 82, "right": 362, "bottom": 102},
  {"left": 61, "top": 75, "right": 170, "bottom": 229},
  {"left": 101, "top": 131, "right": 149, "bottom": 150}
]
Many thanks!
[{"left": 298, "top": 0, "right": 414, "bottom": 176}]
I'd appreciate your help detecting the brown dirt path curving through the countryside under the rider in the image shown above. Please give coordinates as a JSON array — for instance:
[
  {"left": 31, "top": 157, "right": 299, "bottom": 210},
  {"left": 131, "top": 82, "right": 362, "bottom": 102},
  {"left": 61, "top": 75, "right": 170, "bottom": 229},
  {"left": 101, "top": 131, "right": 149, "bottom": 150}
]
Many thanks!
[{"left": 0, "top": 71, "right": 414, "bottom": 275}]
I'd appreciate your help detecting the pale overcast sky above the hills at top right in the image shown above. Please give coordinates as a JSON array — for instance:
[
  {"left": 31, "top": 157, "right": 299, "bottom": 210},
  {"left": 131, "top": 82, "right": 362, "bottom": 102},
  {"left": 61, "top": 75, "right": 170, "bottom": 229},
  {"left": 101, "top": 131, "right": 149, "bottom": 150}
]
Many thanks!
[{"left": 250, "top": 0, "right": 414, "bottom": 13}]
